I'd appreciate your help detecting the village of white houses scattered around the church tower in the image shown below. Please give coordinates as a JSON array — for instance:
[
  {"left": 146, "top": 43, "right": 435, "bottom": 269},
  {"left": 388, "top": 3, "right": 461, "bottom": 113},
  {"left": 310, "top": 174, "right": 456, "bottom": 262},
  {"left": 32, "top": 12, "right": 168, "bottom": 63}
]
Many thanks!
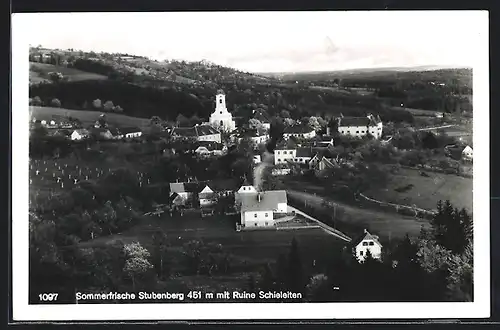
[{"left": 30, "top": 90, "right": 472, "bottom": 262}]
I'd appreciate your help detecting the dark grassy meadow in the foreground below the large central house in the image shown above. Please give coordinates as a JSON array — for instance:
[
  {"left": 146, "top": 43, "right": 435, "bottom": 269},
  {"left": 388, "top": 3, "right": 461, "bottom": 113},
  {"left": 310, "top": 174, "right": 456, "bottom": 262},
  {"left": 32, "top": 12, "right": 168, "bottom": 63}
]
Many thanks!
[{"left": 81, "top": 213, "right": 344, "bottom": 276}]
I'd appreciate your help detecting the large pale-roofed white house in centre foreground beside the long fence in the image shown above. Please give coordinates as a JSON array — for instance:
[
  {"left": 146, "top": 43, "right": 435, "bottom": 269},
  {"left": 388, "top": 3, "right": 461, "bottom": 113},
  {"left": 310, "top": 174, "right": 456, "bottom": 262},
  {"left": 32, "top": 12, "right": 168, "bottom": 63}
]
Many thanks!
[{"left": 239, "top": 190, "right": 288, "bottom": 229}]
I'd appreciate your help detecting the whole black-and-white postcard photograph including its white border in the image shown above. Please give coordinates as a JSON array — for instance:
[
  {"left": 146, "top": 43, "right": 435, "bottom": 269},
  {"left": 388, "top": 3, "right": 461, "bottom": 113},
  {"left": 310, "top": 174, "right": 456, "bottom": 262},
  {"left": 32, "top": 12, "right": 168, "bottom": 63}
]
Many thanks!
[{"left": 12, "top": 11, "right": 490, "bottom": 321}]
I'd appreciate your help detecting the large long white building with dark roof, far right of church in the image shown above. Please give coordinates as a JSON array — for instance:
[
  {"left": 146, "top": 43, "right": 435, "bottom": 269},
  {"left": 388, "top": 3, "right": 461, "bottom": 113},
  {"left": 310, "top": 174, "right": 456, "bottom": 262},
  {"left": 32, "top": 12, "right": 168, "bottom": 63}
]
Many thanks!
[{"left": 338, "top": 114, "right": 383, "bottom": 139}]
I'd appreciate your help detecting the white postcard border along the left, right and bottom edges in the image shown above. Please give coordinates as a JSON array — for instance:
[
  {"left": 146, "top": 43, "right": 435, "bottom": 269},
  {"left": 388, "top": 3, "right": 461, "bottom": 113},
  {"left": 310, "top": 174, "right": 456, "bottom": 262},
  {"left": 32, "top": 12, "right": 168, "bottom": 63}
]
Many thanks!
[{"left": 12, "top": 11, "right": 490, "bottom": 321}]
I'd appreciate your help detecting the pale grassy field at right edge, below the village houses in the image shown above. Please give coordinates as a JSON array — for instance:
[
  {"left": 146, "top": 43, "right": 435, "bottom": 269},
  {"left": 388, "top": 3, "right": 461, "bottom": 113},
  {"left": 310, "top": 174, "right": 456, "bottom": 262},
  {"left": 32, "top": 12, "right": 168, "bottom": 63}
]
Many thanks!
[{"left": 365, "top": 169, "right": 473, "bottom": 212}]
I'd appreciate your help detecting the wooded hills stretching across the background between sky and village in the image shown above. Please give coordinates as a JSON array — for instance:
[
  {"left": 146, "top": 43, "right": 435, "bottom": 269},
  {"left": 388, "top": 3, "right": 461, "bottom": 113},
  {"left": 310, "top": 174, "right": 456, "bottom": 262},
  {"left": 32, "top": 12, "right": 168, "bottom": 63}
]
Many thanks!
[{"left": 30, "top": 48, "right": 472, "bottom": 122}]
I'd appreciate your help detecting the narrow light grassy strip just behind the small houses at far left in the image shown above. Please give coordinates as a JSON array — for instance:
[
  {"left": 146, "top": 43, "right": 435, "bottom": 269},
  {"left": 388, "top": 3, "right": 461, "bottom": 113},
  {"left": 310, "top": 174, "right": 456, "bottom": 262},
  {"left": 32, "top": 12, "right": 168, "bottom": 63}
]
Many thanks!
[{"left": 29, "top": 106, "right": 149, "bottom": 128}]
